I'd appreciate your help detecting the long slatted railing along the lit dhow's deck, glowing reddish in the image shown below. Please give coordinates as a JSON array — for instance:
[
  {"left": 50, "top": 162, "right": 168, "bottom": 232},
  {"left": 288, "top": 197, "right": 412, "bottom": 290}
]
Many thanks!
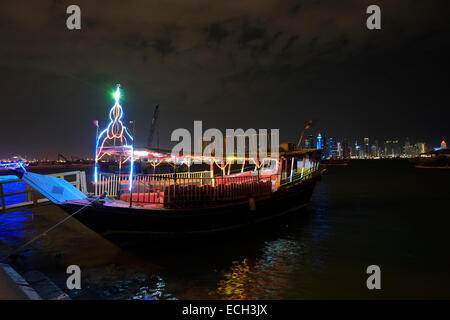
[{"left": 96, "top": 170, "right": 320, "bottom": 207}]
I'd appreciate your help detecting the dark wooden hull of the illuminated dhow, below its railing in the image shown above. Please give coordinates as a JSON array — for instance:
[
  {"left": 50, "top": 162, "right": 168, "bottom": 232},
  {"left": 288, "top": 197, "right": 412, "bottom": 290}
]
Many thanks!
[{"left": 58, "top": 174, "right": 320, "bottom": 238}]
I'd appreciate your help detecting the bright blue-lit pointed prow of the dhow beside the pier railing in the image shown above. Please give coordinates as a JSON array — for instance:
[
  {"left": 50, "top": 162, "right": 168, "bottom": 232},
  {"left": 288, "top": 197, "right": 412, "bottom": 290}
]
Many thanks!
[{"left": 22, "top": 172, "right": 87, "bottom": 203}]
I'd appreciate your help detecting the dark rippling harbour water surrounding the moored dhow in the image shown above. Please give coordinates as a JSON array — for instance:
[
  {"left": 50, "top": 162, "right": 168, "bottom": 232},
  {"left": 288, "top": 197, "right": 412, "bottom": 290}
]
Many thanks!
[{"left": 0, "top": 160, "right": 450, "bottom": 299}]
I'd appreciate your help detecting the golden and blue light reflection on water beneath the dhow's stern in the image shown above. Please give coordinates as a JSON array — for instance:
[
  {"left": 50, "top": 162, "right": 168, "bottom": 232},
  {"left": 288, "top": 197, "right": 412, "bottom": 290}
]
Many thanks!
[{"left": 210, "top": 179, "right": 332, "bottom": 300}]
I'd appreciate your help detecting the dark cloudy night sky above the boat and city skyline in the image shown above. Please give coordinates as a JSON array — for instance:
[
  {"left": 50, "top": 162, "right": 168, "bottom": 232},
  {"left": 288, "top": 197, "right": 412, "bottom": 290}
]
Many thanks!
[{"left": 0, "top": 0, "right": 450, "bottom": 158}]
